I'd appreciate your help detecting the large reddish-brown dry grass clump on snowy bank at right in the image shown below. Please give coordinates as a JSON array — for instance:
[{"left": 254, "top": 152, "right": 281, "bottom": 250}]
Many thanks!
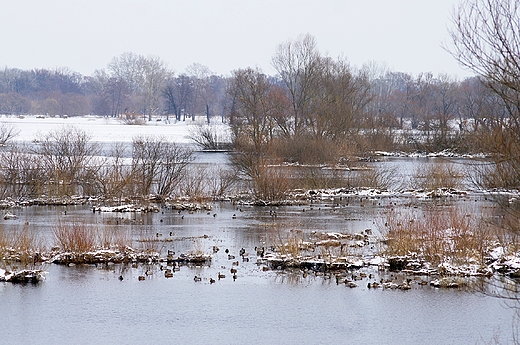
[{"left": 385, "top": 208, "right": 493, "bottom": 265}]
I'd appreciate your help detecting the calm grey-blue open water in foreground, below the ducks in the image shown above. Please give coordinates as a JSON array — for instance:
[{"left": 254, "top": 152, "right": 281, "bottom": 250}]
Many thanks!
[{"left": 0, "top": 260, "right": 512, "bottom": 344}]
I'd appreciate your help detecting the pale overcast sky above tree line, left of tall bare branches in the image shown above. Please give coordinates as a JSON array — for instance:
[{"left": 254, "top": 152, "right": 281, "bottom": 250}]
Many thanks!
[{"left": 0, "top": 0, "right": 471, "bottom": 78}]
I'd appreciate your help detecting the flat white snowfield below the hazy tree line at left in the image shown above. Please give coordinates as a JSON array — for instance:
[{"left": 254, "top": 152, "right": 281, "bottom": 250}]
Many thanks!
[{"left": 0, "top": 116, "right": 229, "bottom": 143}]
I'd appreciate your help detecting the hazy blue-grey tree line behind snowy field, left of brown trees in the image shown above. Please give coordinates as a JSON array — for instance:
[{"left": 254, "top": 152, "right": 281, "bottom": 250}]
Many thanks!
[{"left": 0, "top": 53, "right": 227, "bottom": 120}]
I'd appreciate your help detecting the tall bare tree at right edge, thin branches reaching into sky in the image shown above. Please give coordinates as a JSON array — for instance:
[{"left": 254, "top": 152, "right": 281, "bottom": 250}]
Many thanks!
[{"left": 448, "top": 0, "right": 520, "bottom": 324}]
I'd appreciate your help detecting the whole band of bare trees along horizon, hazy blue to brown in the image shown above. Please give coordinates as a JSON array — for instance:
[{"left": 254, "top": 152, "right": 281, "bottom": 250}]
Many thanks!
[{"left": 0, "top": 35, "right": 507, "bottom": 156}]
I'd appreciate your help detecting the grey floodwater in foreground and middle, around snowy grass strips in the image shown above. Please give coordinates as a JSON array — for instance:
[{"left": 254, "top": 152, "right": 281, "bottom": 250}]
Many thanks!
[{"left": 0, "top": 155, "right": 514, "bottom": 344}]
